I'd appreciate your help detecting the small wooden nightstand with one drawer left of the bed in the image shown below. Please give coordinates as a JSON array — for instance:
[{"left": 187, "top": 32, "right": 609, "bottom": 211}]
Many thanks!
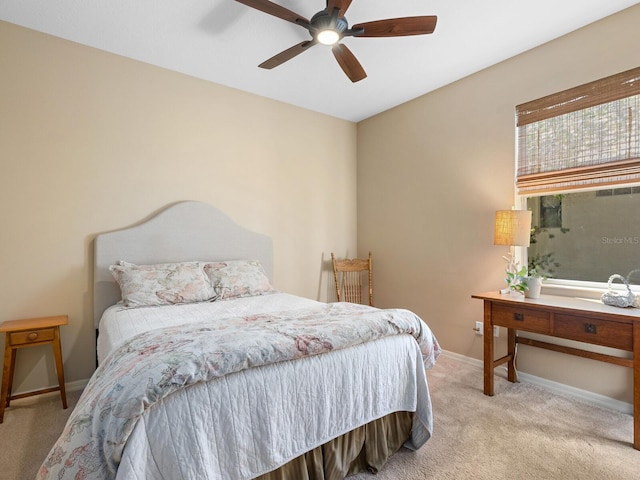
[{"left": 0, "top": 315, "right": 69, "bottom": 423}]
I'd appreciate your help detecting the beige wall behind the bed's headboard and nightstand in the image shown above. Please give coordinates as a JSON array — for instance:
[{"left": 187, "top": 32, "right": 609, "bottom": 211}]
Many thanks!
[{"left": 0, "top": 22, "right": 356, "bottom": 392}]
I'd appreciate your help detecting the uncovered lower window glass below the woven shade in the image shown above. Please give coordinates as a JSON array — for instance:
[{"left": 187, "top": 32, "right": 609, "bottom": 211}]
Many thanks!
[{"left": 527, "top": 187, "right": 640, "bottom": 285}]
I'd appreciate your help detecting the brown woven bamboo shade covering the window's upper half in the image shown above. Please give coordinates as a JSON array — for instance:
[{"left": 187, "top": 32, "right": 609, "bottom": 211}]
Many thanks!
[{"left": 516, "top": 67, "right": 640, "bottom": 195}]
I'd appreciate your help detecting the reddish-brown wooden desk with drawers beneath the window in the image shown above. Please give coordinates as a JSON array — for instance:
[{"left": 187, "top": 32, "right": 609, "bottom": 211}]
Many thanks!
[{"left": 472, "top": 291, "right": 640, "bottom": 450}]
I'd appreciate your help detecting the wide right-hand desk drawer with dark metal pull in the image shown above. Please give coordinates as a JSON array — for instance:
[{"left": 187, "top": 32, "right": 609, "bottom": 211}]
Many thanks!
[{"left": 552, "top": 315, "right": 633, "bottom": 351}]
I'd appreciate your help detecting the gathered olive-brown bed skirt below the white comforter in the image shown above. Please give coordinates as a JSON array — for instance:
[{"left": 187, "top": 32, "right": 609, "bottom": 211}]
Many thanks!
[{"left": 256, "top": 412, "right": 413, "bottom": 480}]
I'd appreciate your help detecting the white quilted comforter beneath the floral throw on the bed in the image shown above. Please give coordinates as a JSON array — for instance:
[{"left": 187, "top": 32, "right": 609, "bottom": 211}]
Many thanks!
[{"left": 45, "top": 294, "right": 439, "bottom": 480}]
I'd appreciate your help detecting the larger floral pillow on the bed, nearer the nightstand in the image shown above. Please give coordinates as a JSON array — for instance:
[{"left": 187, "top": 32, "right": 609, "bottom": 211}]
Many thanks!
[{"left": 109, "top": 261, "right": 216, "bottom": 307}]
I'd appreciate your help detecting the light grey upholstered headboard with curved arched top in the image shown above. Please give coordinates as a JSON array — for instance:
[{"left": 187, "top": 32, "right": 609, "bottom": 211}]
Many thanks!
[{"left": 93, "top": 202, "right": 273, "bottom": 328}]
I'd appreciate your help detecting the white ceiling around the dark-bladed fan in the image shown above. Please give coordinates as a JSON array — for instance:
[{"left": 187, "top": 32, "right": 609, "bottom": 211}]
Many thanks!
[{"left": 0, "top": 0, "right": 639, "bottom": 122}]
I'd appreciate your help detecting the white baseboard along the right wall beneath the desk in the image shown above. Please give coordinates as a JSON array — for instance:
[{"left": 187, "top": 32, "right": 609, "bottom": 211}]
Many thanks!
[{"left": 442, "top": 350, "right": 633, "bottom": 415}]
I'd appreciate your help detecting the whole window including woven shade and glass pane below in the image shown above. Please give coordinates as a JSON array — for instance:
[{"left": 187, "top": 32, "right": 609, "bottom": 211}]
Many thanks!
[{"left": 516, "top": 68, "right": 640, "bottom": 284}]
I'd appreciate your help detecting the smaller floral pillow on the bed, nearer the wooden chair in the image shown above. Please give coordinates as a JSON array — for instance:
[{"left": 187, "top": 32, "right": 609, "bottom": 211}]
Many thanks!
[{"left": 204, "top": 260, "right": 275, "bottom": 300}]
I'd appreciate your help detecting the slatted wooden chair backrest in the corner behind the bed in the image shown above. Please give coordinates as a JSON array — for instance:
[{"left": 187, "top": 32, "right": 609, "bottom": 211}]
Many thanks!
[{"left": 331, "top": 252, "right": 373, "bottom": 306}]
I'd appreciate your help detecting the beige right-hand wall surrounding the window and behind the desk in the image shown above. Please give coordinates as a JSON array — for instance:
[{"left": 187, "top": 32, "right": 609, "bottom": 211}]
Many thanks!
[{"left": 358, "top": 5, "right": 640, "bottom": 402}]
